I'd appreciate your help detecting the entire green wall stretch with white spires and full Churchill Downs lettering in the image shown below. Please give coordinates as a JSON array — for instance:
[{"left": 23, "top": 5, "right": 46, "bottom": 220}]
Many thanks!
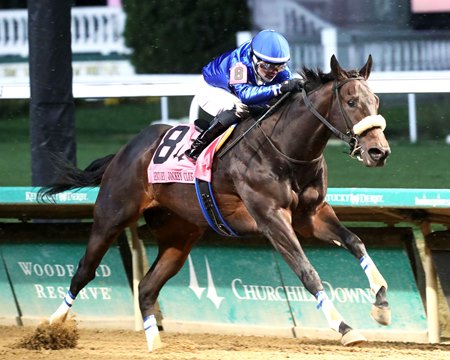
[{"left": 147, "top": 230, "right": 427, "bottom": 341}]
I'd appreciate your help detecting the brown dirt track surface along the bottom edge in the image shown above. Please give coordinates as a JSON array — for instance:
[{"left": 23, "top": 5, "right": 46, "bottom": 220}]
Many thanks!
[{"left": 0, "top": 326, "right": 450, "bottom": 360}]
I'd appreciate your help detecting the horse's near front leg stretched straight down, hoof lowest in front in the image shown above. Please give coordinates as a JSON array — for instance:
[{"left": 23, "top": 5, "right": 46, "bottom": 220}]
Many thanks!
[{"left": 247, "top": 199, "right": 366, "bottom": 345}]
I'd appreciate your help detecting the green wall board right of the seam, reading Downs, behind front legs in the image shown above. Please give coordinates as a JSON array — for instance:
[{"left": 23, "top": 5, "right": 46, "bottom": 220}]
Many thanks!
[{"left": 279, "top": 248, "right": 427, "bottom": 332}]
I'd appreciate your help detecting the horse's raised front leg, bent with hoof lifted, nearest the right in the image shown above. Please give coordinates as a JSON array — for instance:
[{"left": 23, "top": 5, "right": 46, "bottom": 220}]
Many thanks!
[{"left": 294, "top": 203, "right": 391, "bottom": 325}]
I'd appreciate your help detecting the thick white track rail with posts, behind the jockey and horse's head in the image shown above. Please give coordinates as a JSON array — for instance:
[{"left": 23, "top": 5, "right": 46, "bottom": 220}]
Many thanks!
[{"left": 0, "top": 71, "right": 450, "bottom": 142}]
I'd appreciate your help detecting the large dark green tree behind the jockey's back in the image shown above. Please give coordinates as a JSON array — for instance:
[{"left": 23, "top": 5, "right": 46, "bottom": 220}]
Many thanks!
[{"left": 123, "top": 0, "right": 250, "bottom": 74}]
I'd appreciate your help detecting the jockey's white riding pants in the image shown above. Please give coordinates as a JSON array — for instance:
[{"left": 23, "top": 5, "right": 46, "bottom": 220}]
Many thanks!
[{"left": 195, "top": 77, "right": 242, "bottom": 116}]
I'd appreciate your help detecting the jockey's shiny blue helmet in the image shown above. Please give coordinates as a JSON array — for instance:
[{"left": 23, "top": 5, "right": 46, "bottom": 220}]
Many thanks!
[{"left": 252, "top": 30, "right": 291, "bottom": 64}]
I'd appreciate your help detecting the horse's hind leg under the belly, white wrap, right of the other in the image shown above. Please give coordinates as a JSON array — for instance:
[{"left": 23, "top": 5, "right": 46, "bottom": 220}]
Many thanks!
[{"left": 139, "top": 210, "right": 204, "bottom": 351}]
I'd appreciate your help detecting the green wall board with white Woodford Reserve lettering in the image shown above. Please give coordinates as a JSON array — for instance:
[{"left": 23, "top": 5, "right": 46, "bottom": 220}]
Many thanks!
[{"left": 0, "top": 224, "right": 134, "bottom": 328}]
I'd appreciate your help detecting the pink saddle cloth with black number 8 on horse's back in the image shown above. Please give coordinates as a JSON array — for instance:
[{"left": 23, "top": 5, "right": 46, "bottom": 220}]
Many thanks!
[{"left": 147, "top": 124, "right": 225, "bottom": 184}]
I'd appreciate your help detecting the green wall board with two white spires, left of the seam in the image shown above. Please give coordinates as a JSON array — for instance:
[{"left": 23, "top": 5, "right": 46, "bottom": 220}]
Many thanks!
[{"left": 148, "top": 246, "right": 292, "bottom": 328}]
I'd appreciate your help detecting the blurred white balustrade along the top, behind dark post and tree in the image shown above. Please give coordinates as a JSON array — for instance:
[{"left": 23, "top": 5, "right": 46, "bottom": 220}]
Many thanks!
[{"left": 0, "top": 6, "right": 450, "bottom": 71}]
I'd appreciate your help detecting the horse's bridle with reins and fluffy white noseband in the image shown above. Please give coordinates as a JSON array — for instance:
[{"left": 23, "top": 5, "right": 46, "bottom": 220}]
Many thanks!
[{"left": 302, "top": 76, "right": 386, "bottom": 160}]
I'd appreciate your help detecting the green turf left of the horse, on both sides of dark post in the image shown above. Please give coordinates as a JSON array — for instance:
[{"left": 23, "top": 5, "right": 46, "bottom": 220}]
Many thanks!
[{"left": 0, "top": 98, "right": 190, "bottom": 186}]
